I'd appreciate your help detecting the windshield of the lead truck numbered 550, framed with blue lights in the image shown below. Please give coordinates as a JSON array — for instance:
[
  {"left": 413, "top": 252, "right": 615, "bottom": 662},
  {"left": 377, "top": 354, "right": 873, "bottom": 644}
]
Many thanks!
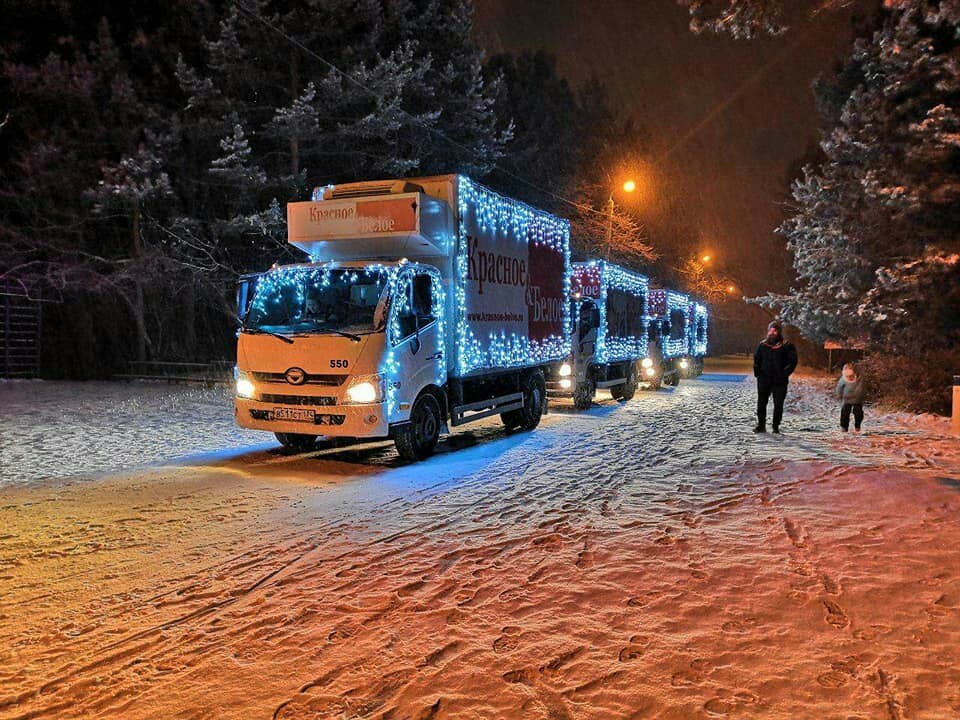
[{"left": 243, "top": 267, "right": 387, "bottom": 334}]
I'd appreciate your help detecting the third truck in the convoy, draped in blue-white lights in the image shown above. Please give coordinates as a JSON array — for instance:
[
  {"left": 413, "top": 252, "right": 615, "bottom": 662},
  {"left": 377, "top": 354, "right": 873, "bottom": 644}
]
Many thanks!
[{"left": 644, "top": 288, "right": 690, "bottom": 389}]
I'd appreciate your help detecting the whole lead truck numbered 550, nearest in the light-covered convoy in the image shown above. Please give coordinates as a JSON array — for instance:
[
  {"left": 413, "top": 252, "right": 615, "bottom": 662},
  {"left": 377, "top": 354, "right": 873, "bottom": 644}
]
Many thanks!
[{"left": 235, "top": 175, "right": 570, "bottom": 460}]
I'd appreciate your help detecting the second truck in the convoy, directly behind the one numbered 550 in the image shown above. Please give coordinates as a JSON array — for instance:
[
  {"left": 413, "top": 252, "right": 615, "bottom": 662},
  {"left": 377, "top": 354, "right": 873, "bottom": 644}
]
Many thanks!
[{"left": 547, "top": 260, "right": 650, "bottom": 410}]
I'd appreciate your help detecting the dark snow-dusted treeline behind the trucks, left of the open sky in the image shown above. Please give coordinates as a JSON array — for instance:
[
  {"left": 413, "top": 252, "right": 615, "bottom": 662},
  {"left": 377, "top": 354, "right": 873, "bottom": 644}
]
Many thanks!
[{"left": 0, "top": 0, "right": 700, "bottom": 378}]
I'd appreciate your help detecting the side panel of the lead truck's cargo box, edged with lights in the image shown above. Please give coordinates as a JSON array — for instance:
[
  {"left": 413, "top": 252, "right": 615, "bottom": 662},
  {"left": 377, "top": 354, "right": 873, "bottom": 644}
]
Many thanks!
[{"left": 449, "top": 176, "right": 570, "bottom": 377}]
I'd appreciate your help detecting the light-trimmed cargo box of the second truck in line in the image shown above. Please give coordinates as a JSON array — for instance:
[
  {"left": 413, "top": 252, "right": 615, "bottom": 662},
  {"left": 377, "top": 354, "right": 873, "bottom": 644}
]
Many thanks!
[{"left": 570, "top": 260, "right": 650, "bottom": 364}]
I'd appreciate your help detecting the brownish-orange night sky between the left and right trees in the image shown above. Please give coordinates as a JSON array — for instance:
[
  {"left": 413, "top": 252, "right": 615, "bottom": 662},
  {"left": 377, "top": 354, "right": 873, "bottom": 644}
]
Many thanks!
[{"left": 475, "top": 0, "right": 870, "bottom": 293}]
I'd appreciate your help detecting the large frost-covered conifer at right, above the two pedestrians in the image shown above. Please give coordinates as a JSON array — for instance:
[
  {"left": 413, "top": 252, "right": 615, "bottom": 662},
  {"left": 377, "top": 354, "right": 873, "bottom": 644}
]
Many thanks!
[{"left": 760, "top": 0, "right": 960, "bottom": 382}]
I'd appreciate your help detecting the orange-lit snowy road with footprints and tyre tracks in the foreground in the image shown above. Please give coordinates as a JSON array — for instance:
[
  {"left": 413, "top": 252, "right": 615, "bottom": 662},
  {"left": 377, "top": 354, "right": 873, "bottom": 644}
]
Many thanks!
[{"left": 0, "top": 362, "right": 960, "bottom": 719}]
